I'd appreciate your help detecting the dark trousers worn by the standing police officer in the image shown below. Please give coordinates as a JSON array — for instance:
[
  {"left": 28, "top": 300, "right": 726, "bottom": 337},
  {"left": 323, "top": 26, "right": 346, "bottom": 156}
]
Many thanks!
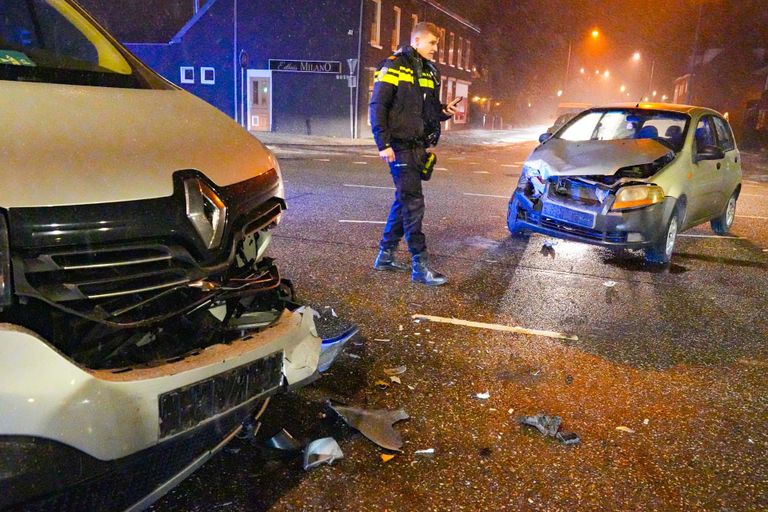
[{"left": 379, "top": 148, "right": 427, "bottom": 254}]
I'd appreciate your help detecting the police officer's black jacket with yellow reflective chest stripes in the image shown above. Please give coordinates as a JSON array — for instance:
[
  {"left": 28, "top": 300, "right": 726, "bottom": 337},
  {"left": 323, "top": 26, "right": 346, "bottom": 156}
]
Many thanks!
[{"left": 369, "top": 46, "right": 451, "bottom": 151}]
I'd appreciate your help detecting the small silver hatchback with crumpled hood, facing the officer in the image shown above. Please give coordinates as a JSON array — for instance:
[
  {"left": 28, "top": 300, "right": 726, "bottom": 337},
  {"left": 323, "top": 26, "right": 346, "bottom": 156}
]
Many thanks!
[{"left": 507, "top": 104, "right": 741, "bottom": 263}]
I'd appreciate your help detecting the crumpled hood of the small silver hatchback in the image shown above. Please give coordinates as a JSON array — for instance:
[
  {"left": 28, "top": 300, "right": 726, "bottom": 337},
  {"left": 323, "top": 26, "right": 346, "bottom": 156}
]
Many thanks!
[{"left": 525, "top": 139, "right": 672, "bottom": 179}]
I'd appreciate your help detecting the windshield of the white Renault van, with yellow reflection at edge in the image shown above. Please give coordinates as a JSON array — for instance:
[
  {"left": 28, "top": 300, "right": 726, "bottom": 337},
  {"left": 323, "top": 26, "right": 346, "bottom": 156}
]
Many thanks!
[{"left": 0, "top": 0, "right": 159, "bottom": 88}]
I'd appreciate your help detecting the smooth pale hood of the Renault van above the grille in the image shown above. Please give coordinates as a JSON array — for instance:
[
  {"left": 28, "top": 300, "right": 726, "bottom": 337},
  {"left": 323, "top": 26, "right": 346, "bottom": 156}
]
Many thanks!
[{"left": 0, "top": 81, "right": 276, "bottom": 208}]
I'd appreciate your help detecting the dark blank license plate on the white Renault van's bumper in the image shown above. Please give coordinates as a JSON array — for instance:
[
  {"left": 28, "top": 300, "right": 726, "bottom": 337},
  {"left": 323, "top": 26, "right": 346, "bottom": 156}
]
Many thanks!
[{"left": 158, "top": 352, "right": 283, "bottom": 438}]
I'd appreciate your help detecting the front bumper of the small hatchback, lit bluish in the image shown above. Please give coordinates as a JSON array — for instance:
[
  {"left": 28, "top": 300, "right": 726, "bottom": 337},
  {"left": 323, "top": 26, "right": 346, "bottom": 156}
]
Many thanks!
[{"left": 507, "top": 188, "right": 675, "bottom": 249}]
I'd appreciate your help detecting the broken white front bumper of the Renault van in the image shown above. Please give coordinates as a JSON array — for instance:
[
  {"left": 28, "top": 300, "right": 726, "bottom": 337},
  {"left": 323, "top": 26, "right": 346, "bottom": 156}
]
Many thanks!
[{"left": 0, "top": 308, "right": 321, "bottom": 511}]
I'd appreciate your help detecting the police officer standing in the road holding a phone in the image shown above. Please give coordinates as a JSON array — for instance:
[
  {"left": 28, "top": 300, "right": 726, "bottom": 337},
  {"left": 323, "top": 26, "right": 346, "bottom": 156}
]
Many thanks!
[{"left": 369, "top": 22, "right": 461, "bottom": 286}]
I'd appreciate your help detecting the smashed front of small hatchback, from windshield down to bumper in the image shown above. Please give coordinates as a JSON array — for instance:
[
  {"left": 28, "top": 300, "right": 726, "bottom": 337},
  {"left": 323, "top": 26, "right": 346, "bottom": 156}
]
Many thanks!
[{"left": 507, "top": 106, "right": 689, "bottom": 264}]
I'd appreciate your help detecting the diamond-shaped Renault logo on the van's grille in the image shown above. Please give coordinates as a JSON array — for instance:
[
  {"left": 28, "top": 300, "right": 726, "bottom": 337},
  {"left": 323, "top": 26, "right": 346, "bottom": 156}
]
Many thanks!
[{"left": 184, "top": 178, "right": 227, "bottom": 249}]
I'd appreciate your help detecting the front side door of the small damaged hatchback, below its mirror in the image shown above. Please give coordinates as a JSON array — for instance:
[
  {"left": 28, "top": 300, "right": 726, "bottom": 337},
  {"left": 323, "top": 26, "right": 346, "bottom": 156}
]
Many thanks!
[{"left": 688, "top": 115, "right": 723, "bottom": 223}]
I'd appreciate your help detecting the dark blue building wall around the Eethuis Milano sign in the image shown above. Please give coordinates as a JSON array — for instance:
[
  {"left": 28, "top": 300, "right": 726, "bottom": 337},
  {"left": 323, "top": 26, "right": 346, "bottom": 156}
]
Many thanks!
[{"left": 127, "top": 0, "right": 360, "bottom": 137}]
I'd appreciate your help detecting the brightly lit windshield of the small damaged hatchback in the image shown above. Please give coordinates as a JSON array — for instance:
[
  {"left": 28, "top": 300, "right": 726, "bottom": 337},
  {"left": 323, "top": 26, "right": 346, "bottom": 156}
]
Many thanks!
[{"left": 556, "top": 109, "right": 690, "bottom": 152}]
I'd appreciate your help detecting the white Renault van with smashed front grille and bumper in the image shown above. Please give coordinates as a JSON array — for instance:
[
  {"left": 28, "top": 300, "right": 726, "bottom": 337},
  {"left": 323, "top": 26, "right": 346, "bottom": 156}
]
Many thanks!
[{"left": 0, "top": 0, "right": 339, "bottom": 512}]
